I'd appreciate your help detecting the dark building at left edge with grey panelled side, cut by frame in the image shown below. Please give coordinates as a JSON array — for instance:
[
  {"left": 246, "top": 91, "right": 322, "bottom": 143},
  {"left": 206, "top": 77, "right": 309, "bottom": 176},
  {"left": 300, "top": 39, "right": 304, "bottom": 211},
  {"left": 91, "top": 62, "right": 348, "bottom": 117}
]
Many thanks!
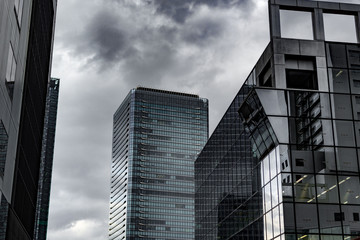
[{"left": 0, "top": 0, "right": 56, "bottom": 240}]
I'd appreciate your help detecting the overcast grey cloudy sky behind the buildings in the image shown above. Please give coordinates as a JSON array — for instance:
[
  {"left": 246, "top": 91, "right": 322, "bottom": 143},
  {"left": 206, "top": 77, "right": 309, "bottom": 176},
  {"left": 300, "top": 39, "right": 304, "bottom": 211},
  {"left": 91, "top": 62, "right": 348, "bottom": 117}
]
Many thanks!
[{"left": 48, "top": 0, "right": 359, "bottom": 240}]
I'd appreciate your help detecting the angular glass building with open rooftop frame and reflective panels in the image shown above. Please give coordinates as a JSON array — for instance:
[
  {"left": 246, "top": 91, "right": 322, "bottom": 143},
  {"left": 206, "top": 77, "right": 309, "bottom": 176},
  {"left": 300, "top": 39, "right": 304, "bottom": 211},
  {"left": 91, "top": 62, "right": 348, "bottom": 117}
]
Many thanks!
[{"left": 195, "top": 0, "right": 360, "bottom": 240}]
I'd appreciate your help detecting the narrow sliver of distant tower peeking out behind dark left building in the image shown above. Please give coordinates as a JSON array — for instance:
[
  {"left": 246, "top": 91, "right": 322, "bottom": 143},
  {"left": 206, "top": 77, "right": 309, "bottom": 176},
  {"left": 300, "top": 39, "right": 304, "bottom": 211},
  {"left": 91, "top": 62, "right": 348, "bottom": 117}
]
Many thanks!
[{"left": 34, "top": 78, "right": 60, "bottom": 240}]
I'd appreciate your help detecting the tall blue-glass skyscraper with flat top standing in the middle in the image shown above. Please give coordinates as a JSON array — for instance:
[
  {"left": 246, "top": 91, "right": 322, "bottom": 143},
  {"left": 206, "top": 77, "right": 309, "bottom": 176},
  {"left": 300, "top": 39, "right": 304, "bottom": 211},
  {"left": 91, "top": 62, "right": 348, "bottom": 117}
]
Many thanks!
[{"left": 109, "top": 87, "right": 208, "bottom": 240}]
